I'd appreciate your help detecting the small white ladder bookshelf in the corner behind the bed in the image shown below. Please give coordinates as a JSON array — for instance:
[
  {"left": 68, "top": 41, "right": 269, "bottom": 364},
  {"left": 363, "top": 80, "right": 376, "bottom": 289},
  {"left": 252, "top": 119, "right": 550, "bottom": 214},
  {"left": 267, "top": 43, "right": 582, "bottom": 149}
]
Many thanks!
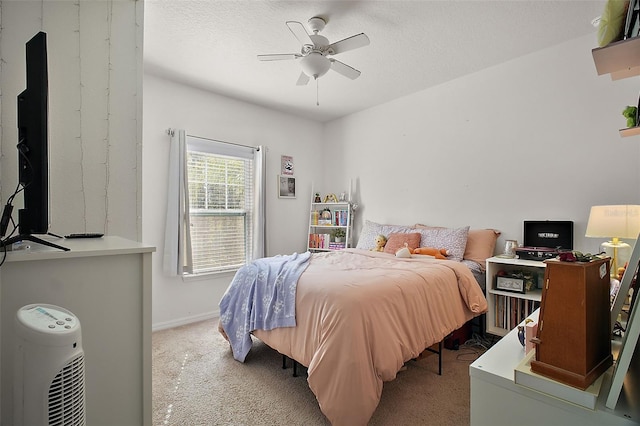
[{"left": 307, "top": 201, "right": 353, "bottom": 251}]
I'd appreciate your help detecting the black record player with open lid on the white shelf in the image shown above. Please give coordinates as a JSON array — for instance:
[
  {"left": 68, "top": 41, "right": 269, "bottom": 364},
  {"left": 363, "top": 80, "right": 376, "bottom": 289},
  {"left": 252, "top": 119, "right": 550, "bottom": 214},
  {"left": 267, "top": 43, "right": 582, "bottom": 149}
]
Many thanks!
[{"left": 516, "top": 220, "right": 573, "bottom": 261}]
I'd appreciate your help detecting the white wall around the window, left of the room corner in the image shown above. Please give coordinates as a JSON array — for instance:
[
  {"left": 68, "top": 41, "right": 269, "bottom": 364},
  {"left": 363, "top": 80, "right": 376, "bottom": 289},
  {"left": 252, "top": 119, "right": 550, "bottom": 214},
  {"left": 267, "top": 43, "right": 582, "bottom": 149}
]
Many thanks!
[{"left": 143, "top": 74, "right": 323, "bottom": 329}]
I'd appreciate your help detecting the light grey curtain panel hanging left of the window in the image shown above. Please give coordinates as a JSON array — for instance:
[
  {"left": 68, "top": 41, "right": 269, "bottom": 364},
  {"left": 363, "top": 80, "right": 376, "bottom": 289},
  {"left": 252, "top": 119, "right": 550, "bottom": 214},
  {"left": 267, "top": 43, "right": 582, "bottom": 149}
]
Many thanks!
[{"left": 163, "top": 129, "right": 193, "bottom": 276}]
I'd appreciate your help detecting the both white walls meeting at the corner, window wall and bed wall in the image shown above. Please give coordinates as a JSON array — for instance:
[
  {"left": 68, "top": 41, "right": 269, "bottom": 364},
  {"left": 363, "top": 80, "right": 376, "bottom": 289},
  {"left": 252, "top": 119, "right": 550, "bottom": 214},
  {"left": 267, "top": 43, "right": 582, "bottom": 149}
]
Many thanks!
[{"left": 148, "top": 32, "right": 640, "bottom": 328}]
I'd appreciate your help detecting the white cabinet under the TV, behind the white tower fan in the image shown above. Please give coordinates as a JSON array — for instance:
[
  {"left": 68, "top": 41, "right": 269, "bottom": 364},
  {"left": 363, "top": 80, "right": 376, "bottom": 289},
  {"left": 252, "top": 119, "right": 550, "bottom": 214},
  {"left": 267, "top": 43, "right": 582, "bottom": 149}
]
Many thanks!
[{"left": 0, "top": 236, "right": 155, "bottom": 426}]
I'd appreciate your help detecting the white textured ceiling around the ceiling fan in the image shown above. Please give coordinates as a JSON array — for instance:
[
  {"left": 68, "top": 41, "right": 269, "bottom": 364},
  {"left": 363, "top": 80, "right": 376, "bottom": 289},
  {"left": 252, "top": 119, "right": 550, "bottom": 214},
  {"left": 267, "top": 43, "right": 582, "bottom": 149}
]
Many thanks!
[{"left": 144, "top": 0, "right": 605, "bottom": 122}]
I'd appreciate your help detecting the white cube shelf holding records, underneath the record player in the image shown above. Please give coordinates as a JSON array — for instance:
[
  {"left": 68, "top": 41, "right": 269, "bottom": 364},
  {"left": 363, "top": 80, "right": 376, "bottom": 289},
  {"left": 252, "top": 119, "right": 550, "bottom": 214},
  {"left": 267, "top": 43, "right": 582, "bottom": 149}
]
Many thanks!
[{"left": 486, "top": 257, "right": 546, "bottom": 336}]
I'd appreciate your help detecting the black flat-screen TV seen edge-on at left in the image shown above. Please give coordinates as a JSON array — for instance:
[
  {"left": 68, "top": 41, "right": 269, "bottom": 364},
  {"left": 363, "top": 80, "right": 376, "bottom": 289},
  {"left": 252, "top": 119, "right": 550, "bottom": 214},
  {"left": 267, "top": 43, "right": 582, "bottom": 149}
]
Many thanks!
[{"left": 18, "top": 32, "right": 49, "bottom": 235}]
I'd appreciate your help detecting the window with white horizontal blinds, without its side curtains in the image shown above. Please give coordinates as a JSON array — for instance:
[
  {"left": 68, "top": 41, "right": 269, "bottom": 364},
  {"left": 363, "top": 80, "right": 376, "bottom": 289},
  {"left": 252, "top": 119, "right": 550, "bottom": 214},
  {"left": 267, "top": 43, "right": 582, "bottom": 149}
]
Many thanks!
[{"left": 187, "top": 138, "right": 254, "bottom": 274}]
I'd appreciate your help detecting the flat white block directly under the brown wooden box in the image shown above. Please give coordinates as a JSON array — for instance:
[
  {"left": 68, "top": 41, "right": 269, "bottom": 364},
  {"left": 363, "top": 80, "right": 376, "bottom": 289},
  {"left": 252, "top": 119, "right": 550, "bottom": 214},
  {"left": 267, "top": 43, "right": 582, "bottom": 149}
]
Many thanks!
[{"left": 514, "top": 349, "right": 604, "bottom": 410}]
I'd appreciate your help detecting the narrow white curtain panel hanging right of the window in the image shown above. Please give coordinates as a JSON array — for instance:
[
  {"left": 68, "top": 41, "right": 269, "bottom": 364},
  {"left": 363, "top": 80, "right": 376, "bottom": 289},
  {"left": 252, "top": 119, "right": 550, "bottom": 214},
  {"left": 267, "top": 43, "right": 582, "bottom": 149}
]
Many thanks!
[{"left": 252, "top": 146, "right": 267, "bottom": 260}]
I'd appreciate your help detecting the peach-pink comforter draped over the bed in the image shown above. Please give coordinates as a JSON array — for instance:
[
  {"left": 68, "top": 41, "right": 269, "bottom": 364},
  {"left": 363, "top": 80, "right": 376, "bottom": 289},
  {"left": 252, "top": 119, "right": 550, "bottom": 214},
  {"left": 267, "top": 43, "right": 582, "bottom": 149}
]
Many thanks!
[{"left": 253, "top": 249, "right": 487, "bottom": 426}]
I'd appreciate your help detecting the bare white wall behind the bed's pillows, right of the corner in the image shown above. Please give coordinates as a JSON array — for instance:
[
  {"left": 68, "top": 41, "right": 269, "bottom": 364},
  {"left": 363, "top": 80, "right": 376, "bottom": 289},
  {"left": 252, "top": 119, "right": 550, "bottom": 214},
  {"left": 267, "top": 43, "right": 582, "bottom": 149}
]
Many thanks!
[{"left": 324, "top": 34, "right": 640, "bottom": 252}]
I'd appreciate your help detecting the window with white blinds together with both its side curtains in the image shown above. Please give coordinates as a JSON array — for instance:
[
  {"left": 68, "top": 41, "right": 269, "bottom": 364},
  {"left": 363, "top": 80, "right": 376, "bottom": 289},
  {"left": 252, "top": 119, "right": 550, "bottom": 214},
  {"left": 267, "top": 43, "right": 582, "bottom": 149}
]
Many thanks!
[{"left": 162, "top": 129, "right": 266, "bottom": 277}]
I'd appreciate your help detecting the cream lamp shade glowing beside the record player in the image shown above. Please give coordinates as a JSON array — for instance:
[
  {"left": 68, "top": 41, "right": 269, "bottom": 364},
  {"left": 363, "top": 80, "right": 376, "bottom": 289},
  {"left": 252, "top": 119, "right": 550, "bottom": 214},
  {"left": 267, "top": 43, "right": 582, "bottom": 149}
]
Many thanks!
[{"left": 585, "top": 205, "right": 640, "bottom": 239}]
